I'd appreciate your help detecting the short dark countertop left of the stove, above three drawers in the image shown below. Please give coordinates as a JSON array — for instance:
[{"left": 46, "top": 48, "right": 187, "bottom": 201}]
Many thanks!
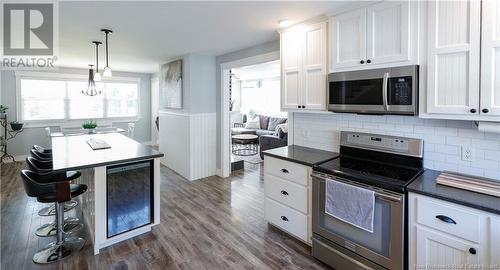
[{"left": 263, "top": 145, "right": 339, "bottom": 166}]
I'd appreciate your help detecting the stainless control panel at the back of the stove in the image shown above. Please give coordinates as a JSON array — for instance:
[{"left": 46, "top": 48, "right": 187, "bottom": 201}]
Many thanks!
[{"left": 340, "top": 131, "right": 423, "bottom": 157}]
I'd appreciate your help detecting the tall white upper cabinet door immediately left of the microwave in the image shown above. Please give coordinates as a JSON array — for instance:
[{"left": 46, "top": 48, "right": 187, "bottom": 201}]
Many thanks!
[{"left": 302, "top": 22, "right": 327, "bottom": 110}]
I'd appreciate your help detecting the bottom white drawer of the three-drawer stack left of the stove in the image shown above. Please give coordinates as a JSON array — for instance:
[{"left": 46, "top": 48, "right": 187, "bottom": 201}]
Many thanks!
[{"left": 265, "top": 198, "right": 307, "bottom": 242}]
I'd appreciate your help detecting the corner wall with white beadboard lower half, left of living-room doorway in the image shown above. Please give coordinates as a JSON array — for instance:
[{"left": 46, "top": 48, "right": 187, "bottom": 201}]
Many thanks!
[{"left": 159, "top": 54, "right": 217, "bottom": 180}]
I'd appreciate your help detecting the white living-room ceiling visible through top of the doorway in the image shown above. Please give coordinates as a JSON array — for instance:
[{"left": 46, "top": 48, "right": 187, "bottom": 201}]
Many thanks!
[{"left": 231, "top": 61, "right": 280, "bottom": 81}]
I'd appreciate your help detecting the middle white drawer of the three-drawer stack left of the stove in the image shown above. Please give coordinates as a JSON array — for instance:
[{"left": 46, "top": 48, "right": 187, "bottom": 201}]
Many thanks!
[{"left": 264, "top": 174, "right": 308, "bottom": 214}]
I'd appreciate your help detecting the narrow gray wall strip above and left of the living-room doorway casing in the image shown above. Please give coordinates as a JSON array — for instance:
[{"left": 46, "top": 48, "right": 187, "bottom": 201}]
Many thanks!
[{"left": 215, "top": 40, "right": 280, "bottom": 169}]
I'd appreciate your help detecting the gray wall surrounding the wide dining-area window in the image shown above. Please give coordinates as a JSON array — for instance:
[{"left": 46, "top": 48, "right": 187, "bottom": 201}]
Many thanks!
[{"left": 0, "top": 68, "right": 151, "bottom": 156}]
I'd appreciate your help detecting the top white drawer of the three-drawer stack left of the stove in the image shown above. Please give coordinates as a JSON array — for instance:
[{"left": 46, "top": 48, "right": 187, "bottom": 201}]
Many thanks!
[{"left": 264, "top": 156, "right": 309, "bottom": 186}]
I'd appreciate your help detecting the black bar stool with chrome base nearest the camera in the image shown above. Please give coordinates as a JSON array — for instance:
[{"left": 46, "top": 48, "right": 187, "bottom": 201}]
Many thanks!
[{"left": 21, "top": 170, "right": 87, "bottom": 264}]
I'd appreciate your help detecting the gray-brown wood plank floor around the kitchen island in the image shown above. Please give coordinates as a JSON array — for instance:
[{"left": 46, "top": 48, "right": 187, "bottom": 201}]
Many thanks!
[{"left": 0, "top": 162, "right": 327, "bottom": 270}]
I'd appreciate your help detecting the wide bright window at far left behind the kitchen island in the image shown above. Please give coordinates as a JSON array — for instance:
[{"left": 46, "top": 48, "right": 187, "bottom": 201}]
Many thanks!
[{"left": 18, "top": 73, "right": 139, "bottom": 122}]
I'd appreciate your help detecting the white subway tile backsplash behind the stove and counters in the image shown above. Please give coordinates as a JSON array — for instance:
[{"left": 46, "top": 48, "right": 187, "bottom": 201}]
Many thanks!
[{"left": 293, "top": 113, "right": 500, "bottom": 181}]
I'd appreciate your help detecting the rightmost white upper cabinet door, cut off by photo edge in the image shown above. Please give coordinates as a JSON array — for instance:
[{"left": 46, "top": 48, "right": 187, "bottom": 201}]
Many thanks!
[{"left": 480, "top": 0, "right": 500, "bottom": 116}]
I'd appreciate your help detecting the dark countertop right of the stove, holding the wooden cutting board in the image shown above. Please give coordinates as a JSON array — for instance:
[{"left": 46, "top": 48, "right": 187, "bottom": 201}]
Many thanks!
[{"left": 408, "top": 170, "right": 500, "bottom": 215}]
